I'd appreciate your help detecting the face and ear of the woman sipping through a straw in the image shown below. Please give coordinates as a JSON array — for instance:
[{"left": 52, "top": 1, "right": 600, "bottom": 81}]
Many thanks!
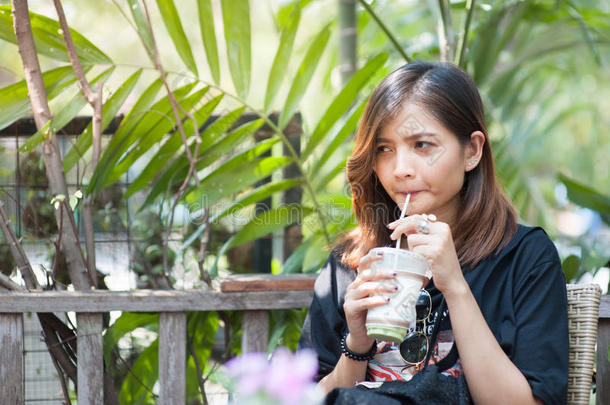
[{"left": 375, "top": 103, "right": 478, "bottom": 224}]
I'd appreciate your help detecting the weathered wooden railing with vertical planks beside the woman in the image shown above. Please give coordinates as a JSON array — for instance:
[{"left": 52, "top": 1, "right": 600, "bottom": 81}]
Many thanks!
[{"left": 0, "top": 275, "right": 610, "bottom": 405}]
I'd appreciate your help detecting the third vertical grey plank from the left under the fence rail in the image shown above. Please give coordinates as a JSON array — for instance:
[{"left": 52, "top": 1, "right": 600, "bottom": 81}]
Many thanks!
[{"left": 159, "top": 312, "right": 186, "bottom": 405}]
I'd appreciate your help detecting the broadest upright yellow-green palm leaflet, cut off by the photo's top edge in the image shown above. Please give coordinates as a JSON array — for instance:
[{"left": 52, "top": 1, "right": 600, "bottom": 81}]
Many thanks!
[{"left": 221, "top": 0, "right": 251, "bottom": 99}]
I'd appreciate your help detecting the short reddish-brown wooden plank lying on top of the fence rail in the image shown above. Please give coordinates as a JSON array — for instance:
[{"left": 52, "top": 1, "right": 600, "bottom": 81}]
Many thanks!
[{"left": 220, "top": 273, "right": 317, "bottom": 292}]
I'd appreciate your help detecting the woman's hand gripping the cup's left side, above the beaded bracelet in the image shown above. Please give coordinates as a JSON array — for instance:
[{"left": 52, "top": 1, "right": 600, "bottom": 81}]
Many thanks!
[{"left": 343, "top": 253, "right": 397, "bottom": 353}]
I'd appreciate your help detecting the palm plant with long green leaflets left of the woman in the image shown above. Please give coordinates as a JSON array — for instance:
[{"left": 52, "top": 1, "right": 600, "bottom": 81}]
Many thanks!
[{"left": 0, "top": 0, "right": 387, "bottom": 403}]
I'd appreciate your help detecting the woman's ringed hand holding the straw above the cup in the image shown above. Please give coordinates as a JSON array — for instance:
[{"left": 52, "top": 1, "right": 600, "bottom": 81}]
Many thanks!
[{"left": 388, "top": 215, "right": 467, "bottom": 295}]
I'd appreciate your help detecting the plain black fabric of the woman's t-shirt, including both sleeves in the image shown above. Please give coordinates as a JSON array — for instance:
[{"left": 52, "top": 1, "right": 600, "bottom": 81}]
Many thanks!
[{"left": 299, "top": 225, "right": 568, "bottom": 404}]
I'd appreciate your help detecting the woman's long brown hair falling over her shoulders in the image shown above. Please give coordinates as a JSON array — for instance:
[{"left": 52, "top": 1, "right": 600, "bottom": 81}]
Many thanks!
[{"left": 337, "top": 62, "right": 517, "bottom": 268}]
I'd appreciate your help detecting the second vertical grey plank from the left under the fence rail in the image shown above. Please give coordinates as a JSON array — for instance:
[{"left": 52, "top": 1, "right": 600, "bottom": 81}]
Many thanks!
[{"left": 76, "top": 313, "right": 104, "bottom": 404}]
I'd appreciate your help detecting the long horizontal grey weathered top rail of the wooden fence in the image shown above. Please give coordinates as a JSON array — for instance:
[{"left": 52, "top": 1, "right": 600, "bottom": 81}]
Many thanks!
[{"left": 0, "top": 290, "right": 313, "bottom": 313}]
